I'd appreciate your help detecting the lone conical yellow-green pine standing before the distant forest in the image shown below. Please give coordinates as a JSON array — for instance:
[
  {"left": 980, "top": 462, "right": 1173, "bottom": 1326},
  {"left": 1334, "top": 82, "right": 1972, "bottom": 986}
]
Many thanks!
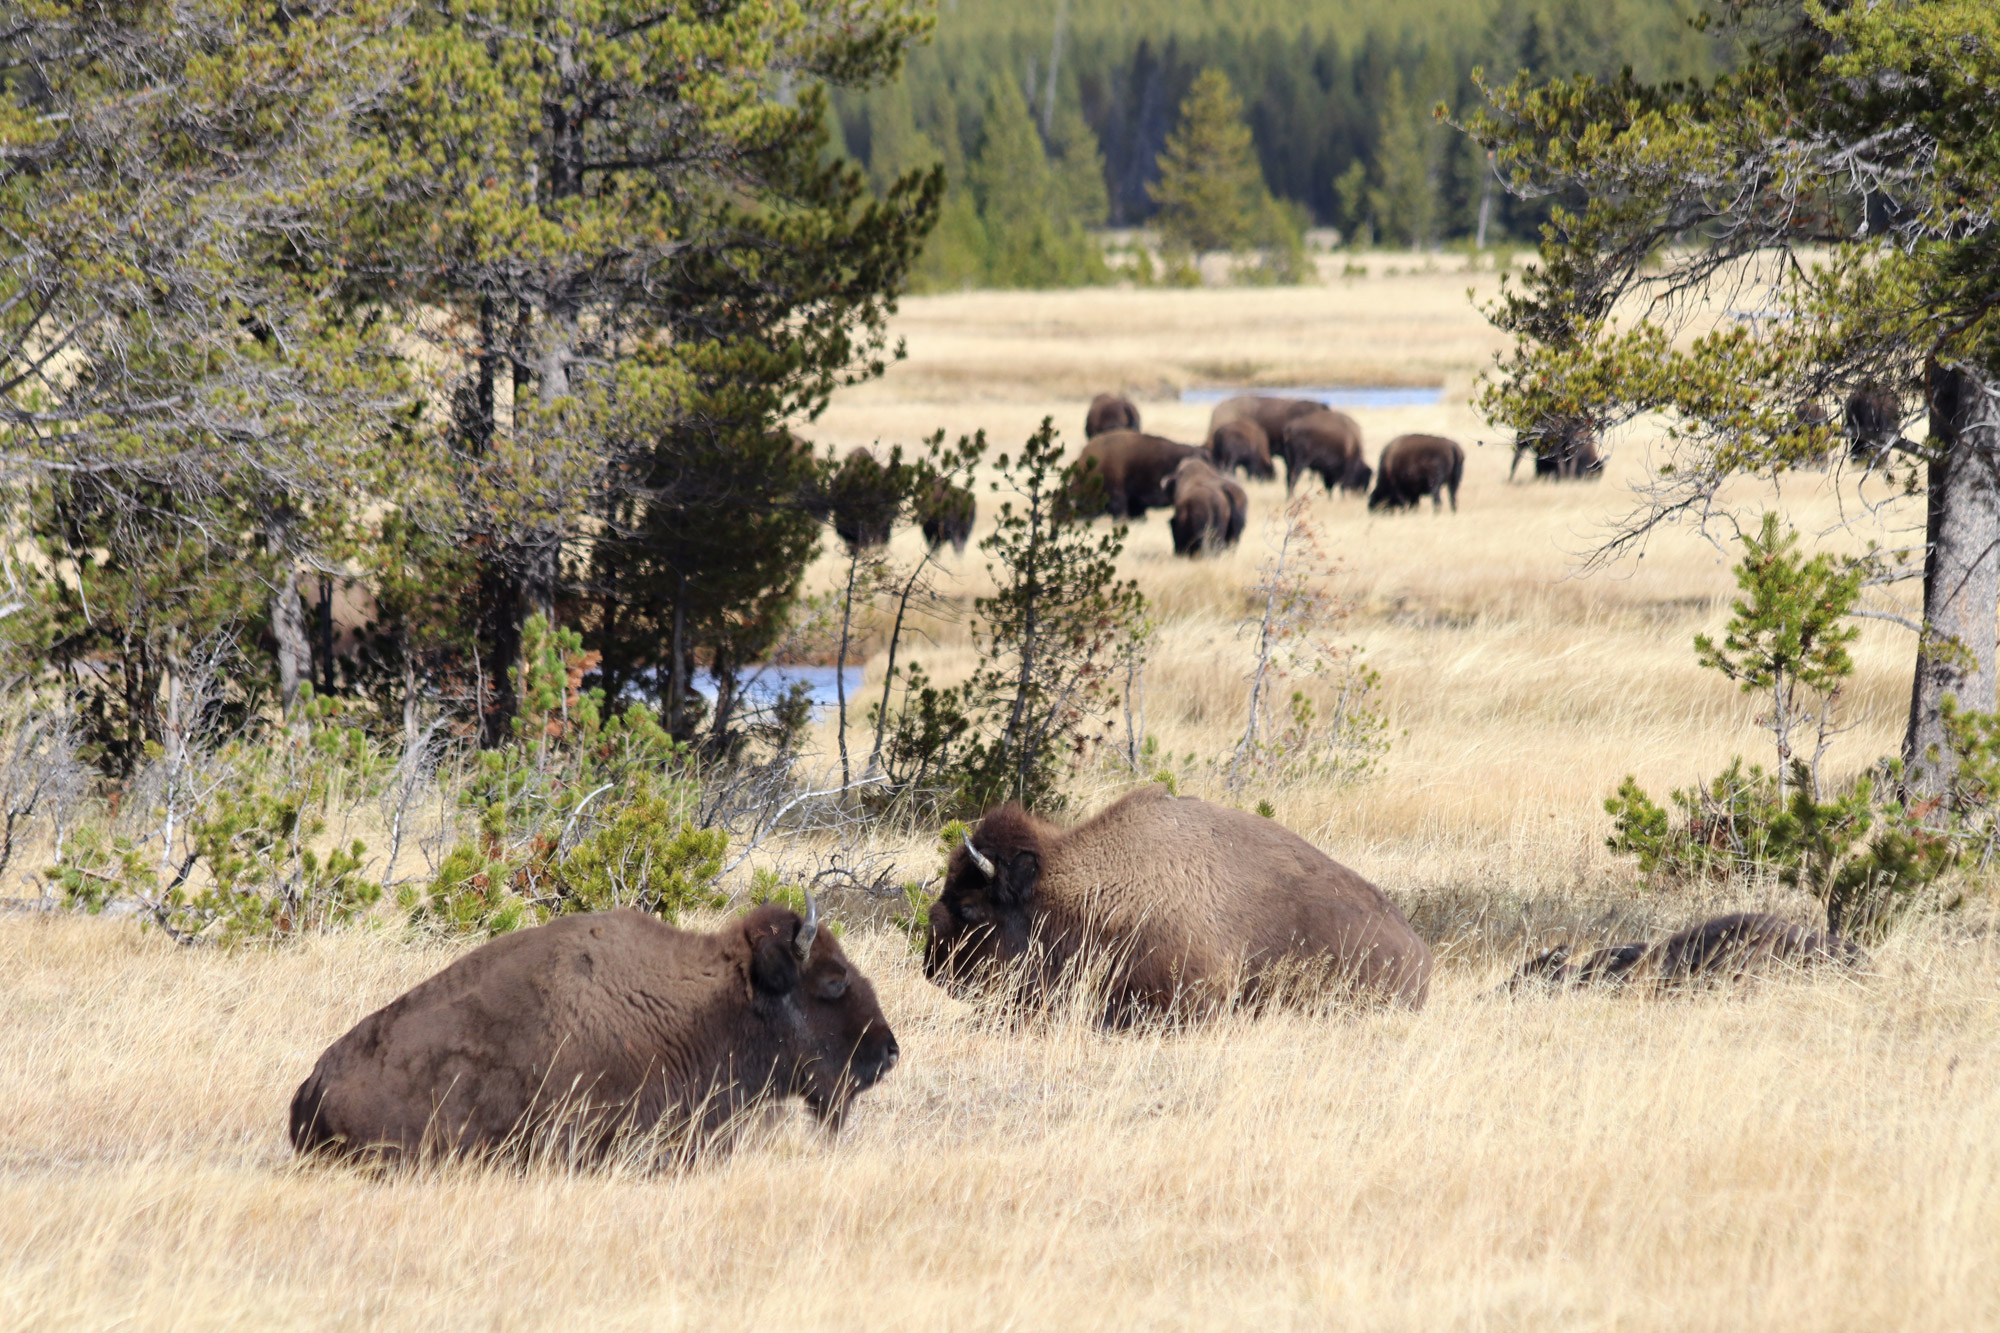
[{"left": 1146, "top": 68, "right": 1268, "bottom": 254}]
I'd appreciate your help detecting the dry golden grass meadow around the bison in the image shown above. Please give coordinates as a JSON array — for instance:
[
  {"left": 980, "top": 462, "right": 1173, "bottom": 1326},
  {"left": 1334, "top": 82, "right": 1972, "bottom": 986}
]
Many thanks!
[{"left": 0, "top": 256, "right": 2000, "bottom": 1329}]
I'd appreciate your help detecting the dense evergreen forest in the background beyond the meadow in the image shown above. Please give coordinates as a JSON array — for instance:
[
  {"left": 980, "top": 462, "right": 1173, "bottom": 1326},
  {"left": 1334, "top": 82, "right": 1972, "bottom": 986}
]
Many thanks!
[{"left": 836, "top": 0, "right": 1718, "bottom": 284}]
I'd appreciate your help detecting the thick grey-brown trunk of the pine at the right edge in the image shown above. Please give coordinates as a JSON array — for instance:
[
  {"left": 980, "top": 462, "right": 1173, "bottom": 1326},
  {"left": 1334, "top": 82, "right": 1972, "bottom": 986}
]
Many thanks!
[{"left": 1902, "top": 366, "right": 2000, "bottom": 795}]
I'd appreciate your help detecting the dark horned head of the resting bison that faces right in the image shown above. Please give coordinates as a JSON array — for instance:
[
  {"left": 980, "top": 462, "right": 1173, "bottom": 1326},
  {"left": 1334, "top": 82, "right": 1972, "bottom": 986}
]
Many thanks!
[{"left": 744, "top": 895, "right": 898, "bottom": 1127}]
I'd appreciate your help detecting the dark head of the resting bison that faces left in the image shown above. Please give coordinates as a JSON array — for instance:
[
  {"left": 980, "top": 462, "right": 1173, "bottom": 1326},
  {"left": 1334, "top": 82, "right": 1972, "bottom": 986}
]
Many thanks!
[{"left": 924, "top": 805, "right": 1042, "bottom": 995}]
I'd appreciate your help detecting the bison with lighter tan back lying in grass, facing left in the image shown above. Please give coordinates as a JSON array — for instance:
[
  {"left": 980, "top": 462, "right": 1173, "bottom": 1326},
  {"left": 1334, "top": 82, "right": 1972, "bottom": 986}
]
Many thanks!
[{"left": 924, "top": 787, "right": 1432, "bottom": 1021}]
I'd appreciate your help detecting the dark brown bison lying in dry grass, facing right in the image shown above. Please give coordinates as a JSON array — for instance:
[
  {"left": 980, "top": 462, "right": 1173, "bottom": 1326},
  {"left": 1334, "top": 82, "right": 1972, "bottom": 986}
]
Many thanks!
[{"left": 292, "top": 901, "right": 896, "bottom": 1159}]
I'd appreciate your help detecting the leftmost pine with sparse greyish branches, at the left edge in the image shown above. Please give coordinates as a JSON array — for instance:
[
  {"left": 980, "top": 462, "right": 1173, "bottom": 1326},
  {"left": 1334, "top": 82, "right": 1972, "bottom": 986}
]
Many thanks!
[{"left": 0, "top": 0, "right": 408, "bottom": 756}]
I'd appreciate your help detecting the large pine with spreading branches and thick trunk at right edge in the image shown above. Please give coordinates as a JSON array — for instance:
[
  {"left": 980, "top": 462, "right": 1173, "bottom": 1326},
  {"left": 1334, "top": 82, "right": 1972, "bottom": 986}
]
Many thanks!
[{"left": 1474, "top": 0, "right": 2000, "bottom": 793}]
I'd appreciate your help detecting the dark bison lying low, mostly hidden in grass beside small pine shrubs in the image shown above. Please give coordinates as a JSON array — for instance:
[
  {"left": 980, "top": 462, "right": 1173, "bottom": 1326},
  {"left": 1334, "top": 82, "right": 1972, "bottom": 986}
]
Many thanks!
[{"left": 1508, "top": 913, "right": 1868, "bottom": 989}]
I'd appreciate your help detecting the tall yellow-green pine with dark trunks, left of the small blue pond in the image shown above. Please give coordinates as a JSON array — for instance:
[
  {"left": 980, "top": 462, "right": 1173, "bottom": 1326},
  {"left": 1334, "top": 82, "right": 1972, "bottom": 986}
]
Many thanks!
[{"left": 358, "top": 0, "right": 942, "bottom": 741}]
